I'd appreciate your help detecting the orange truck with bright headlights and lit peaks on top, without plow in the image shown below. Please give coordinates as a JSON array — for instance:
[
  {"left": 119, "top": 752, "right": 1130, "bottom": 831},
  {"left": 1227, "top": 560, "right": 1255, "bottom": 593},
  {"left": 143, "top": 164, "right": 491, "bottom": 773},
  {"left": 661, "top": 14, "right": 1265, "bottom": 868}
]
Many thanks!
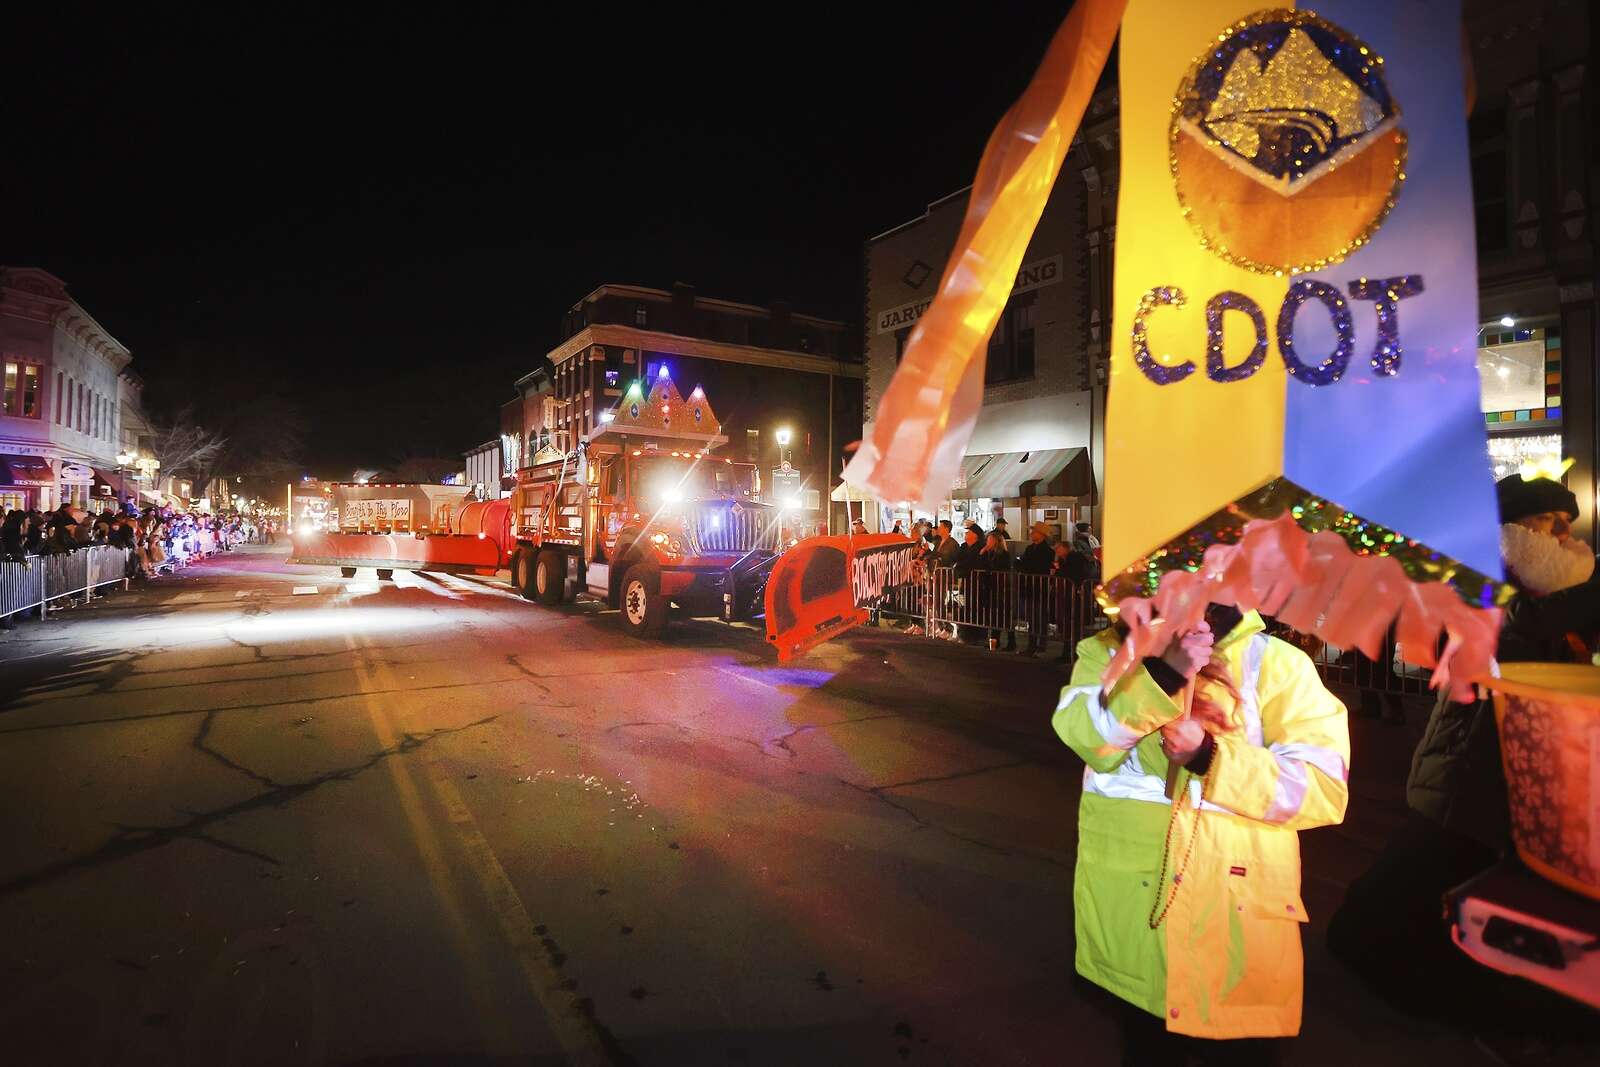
[{"left": 510, "top": 374, "right": 787, "bottom": 637}]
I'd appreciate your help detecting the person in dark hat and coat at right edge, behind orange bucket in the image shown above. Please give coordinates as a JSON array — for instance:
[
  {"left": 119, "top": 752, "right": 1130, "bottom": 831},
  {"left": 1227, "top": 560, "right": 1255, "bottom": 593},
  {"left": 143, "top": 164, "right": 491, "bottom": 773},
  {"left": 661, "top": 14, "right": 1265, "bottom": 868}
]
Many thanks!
[{"left": 1328, "top": 474, "right": 1600, "bottom": 1025}]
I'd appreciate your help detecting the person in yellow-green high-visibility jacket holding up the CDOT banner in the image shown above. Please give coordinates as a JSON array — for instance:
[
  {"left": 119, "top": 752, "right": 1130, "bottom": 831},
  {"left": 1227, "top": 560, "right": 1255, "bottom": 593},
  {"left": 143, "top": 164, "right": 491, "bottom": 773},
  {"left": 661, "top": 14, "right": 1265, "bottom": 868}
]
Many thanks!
[{"left": 1054, "top": 605, "right": 1350, "bottom": 1062}]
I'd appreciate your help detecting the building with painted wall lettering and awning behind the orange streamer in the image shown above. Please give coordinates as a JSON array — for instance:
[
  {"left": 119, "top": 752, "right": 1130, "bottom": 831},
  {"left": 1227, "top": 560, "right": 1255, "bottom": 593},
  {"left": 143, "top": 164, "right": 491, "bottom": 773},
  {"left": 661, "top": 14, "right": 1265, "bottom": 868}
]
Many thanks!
[{"left": 864, "top": 90, "right": 1117, "bottom": 533}]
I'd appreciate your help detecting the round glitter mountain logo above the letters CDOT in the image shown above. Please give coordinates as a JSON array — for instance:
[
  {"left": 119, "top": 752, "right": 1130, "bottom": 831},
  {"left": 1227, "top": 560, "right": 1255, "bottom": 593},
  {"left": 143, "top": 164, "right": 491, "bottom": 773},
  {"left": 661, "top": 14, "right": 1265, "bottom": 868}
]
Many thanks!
[{"left": 1170, "top": 10, "right": 1406, "bottom": 275}]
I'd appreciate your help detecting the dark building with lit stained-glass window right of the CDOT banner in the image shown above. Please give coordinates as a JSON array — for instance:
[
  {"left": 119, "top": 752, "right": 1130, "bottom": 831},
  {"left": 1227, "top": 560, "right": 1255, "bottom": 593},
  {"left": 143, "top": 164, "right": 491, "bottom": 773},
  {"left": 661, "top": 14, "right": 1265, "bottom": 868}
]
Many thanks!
[{"left": 1466, "top": 0, "right": 1600, "bottom": 544}]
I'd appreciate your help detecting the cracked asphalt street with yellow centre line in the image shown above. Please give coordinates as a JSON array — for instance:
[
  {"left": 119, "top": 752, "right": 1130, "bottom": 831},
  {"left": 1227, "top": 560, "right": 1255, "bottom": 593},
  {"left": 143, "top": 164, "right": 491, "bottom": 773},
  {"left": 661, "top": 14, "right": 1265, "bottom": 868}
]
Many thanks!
[{"left": 0, "top": 547, "right": 1578, "bottom": 1067}]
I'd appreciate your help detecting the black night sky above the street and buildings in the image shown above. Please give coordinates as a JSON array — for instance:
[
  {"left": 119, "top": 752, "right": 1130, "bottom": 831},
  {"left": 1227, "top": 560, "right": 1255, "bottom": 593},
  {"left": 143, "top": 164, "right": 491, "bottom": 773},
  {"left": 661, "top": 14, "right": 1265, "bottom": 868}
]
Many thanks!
[{"left": 0, "top": 0, "right": 1069, "bottom": 474}]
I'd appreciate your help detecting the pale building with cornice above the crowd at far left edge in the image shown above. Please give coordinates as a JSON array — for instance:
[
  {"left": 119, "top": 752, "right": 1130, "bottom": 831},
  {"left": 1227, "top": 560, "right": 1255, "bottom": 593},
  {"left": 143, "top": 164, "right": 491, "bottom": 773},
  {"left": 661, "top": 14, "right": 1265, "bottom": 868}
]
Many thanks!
[{"left": 0, "top": 267, "right": 131, "bottom": 509}]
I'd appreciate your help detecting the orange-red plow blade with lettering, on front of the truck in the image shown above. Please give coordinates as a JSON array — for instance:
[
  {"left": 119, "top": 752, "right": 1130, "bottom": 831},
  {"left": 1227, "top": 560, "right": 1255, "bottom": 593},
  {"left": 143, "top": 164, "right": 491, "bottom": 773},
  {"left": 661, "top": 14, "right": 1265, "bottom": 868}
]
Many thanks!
[{"left": 766, "top": 534, "right": 918, "bottom": 662}]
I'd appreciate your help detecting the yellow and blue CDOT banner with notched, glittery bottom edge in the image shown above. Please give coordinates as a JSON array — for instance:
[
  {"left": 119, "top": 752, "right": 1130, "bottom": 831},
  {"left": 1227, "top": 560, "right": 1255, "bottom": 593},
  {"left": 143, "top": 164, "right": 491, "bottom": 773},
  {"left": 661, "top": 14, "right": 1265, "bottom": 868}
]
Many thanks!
[{"left": 1104, "top": 0, "right": 1501, "bottom": 605}]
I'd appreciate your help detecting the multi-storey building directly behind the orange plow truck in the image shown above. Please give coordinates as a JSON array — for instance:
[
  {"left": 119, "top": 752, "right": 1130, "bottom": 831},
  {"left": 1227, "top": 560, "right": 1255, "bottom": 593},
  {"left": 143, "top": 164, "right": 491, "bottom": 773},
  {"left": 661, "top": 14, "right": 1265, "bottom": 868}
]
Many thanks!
[{"left": 501, "top": 285, "right": 864, "bottom": 528}]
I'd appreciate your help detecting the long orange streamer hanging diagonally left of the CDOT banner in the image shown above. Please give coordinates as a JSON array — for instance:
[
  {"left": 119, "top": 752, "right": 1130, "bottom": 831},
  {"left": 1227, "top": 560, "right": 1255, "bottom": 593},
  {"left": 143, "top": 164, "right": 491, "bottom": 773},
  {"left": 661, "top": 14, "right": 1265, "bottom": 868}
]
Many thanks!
[{"left": 845, "top": 0, "right": 1126, "bottom": 510}]
